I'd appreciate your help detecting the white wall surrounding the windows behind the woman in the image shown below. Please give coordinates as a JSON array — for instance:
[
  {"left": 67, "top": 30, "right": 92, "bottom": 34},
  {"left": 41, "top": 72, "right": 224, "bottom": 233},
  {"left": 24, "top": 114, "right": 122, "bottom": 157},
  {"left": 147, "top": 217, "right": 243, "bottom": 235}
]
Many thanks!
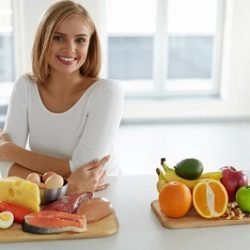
[{"left": 14, "top": 0, "right": 250, "bottom": 120}]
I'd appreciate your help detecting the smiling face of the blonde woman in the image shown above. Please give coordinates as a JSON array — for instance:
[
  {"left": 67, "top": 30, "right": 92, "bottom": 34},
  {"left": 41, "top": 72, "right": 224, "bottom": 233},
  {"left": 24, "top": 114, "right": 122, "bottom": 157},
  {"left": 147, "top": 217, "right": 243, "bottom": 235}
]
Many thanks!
[{"left": 48, "top": 15, "right": 91, "bottom": 74}]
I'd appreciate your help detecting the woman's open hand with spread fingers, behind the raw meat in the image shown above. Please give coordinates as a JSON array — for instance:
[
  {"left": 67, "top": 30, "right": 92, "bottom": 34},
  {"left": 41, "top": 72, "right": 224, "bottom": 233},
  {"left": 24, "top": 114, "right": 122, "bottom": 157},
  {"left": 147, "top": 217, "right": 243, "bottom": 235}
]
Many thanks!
[{"left": 67, "top": 156, "right": 110, "bottom": 194}]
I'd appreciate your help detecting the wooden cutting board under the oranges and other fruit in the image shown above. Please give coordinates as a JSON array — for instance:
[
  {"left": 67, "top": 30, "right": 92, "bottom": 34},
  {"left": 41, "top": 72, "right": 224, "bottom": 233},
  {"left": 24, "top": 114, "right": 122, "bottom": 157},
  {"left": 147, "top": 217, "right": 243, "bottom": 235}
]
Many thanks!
[{"left": 151, "top": 200, "right": 250, "bottom": 229}]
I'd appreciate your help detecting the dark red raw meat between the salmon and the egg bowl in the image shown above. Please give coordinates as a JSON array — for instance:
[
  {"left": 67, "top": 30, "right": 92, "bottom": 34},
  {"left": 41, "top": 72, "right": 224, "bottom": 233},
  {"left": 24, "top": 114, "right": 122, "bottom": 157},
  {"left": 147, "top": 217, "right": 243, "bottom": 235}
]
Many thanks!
[{"left": 43, "top": 192, "right": 94, "bottom": 214}]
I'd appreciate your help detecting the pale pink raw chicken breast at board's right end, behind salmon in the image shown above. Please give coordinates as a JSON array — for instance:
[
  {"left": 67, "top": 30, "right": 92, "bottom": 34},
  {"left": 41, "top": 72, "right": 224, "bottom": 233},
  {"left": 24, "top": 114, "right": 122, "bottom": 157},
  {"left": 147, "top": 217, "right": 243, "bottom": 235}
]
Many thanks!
[{"left": 76, "top": 197, "right": 113, "bottom": 223}]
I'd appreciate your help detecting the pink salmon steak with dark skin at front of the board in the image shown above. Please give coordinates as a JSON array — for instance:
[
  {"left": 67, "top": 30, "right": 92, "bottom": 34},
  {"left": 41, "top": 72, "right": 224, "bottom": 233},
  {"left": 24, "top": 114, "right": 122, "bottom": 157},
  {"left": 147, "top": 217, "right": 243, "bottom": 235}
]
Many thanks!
[{"left": 22, "top": 210, "right": 87, "bottom": 234}]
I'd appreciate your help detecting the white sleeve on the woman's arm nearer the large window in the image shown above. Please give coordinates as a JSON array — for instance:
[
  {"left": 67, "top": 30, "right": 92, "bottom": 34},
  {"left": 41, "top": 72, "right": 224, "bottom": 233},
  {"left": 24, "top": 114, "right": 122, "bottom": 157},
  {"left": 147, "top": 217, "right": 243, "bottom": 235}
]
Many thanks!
[{"left": 70, "top": 82, "right": 123, "bottom": 172}]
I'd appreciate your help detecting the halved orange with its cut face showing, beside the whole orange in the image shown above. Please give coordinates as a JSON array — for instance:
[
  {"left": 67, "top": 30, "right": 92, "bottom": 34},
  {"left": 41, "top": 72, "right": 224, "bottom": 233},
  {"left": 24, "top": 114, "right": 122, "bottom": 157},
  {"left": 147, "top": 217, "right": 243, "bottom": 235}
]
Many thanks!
[{"left": 193, "top": 179, "right": 228, "bottom": 218}]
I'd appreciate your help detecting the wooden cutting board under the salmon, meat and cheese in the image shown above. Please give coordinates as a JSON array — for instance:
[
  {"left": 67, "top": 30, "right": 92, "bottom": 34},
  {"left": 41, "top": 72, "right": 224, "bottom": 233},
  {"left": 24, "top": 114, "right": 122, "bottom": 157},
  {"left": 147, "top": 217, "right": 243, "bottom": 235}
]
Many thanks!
[{"left": 0, "top": 212, "right": 119, "bottom": 243}]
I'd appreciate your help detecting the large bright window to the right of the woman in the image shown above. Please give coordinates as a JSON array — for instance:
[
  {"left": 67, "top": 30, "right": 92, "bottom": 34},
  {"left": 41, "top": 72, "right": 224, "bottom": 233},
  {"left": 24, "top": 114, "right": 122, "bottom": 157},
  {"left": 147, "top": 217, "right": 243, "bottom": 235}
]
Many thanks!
[{"left": 106, "top": 0, "right": 224, "bottom": 97}]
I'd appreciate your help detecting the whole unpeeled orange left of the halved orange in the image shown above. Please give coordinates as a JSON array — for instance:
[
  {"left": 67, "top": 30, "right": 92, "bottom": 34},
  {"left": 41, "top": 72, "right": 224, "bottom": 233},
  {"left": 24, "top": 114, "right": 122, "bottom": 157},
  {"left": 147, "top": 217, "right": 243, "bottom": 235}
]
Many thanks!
[{"left": 159, "top": 181, "right": 192, "bottom": 218}]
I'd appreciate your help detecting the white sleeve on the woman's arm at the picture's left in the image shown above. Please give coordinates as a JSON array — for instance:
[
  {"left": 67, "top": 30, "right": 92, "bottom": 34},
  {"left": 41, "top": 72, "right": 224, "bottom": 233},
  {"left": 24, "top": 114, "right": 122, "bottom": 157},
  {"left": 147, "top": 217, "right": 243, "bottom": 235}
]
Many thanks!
[{"left": 0, "top": 77, "right": 28, "bottom": 177}]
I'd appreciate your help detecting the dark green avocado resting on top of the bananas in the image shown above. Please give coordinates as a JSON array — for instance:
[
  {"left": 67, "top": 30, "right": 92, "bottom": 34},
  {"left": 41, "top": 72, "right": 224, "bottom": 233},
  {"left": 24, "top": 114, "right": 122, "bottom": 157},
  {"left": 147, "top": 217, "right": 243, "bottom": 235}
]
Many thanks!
[{"left": 174, "top": 158, "right": 203, "bottom": 180}]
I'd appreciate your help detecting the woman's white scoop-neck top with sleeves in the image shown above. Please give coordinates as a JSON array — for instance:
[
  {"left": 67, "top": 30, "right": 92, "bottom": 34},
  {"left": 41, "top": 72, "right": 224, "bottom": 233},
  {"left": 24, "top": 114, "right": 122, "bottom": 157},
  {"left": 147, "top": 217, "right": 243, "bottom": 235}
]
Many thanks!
[{"left": 0, "top": 76, "right": 123, "bottom": 177}]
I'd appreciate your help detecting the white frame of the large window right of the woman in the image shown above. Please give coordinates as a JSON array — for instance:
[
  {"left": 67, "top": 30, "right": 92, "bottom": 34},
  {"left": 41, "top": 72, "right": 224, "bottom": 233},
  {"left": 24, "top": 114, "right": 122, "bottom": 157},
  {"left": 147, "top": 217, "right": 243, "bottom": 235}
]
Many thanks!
[{"left": 105, "top": 0, "right": 226, "bottom": 99}]
